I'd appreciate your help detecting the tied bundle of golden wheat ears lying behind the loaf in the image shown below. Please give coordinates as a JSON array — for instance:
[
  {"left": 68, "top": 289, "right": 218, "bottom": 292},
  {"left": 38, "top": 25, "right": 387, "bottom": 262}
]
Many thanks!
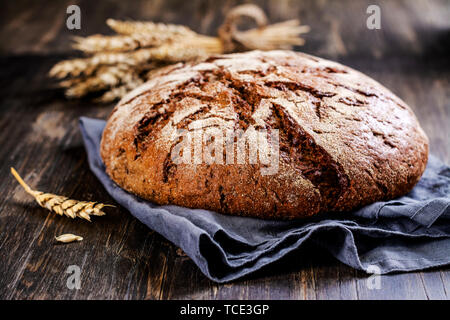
[{"left": 49, "top": 4, "right": 309, "bottom": 102}]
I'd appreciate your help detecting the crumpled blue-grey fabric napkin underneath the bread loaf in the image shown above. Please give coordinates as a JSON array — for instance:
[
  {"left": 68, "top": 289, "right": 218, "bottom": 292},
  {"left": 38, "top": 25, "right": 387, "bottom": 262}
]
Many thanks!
[{"left": 80, "top": 118, "right": 450, "bottom": 282}]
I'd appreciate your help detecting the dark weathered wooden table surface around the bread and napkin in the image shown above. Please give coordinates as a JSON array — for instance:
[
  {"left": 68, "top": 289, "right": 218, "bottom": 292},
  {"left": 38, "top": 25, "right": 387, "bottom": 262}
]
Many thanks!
[{"left": 0, "top": 0, "right": 450, "bottom": 299}]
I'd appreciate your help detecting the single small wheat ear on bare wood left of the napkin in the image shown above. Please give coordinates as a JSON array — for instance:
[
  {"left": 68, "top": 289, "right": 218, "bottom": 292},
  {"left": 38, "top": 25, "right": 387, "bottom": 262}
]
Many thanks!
[{"left": 11, "top": 168, "right": 114, "bottom": 221}]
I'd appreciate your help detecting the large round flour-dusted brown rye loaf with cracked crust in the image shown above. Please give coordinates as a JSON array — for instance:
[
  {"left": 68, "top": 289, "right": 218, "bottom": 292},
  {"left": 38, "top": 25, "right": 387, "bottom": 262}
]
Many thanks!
[{"left": 101, "top": 51, "right": 428, "bottom": 219}]
